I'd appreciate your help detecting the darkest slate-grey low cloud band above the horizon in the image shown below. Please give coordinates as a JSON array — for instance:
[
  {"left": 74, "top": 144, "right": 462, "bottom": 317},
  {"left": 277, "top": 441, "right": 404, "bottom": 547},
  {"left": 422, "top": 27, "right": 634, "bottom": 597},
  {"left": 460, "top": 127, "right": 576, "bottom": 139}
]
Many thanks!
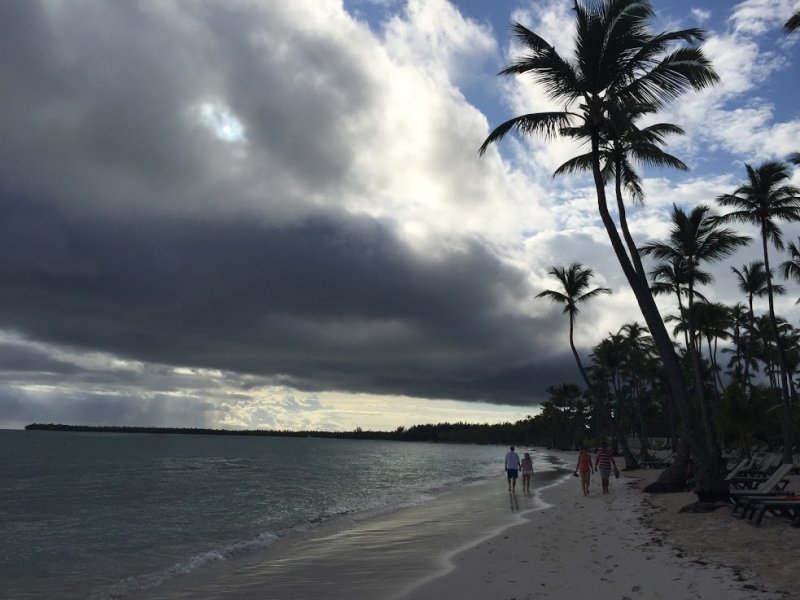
[{"left": 0, "top": 200, "right": 569, "bottom": 403}]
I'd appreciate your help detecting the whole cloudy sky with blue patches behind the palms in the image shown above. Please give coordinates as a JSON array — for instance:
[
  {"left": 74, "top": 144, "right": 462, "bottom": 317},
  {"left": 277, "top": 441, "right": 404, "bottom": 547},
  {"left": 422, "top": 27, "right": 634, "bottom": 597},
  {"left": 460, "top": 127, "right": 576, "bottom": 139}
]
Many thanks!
[{"left": 0, "top": 0, "right": 800, "bottom": 431}]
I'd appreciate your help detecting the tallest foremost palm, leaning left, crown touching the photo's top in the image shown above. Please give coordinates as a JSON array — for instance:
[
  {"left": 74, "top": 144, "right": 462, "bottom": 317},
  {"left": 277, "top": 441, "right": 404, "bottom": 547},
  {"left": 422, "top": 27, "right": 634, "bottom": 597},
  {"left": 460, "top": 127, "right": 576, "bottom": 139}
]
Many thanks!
[{"left": 479, "top": 0, "right": 727, "bottom": 499}]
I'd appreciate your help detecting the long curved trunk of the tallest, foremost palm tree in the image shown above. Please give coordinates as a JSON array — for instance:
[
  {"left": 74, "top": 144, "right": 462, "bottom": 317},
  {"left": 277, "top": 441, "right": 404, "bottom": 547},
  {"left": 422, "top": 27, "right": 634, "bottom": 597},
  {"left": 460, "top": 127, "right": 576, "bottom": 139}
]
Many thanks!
[{"left": 587, "top": 127, "right": 728, "bottom": 500}]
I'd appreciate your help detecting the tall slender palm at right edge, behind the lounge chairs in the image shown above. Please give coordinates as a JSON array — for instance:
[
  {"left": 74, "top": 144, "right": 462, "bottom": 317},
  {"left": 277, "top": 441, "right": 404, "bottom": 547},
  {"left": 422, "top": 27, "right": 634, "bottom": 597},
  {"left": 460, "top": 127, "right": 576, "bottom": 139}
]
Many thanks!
[{"left": 717, "top": 161, "right": 800, "bottom": 462}]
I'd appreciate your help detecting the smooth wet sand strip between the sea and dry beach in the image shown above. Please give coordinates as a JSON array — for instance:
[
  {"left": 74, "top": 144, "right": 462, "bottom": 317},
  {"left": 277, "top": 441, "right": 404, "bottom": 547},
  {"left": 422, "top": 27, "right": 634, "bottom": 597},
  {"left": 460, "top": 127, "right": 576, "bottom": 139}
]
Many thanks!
[{"left": 136, "top": 472, "right": 563, "bottom": 600}]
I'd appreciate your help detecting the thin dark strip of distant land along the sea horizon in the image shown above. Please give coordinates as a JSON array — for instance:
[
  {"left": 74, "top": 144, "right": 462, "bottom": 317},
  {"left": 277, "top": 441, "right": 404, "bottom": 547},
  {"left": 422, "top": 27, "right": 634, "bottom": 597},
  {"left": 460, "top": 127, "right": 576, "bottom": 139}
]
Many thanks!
[{"left": 25, "top": 418, "right": 542, "bottom": 445}]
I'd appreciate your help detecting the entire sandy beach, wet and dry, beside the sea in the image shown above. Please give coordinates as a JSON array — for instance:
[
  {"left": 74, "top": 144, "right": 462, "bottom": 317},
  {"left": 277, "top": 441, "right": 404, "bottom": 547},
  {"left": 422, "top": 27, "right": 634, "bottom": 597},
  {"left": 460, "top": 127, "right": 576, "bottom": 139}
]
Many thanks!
[{"left": 133, "top": 454, "right": 800, "bottom": 600}]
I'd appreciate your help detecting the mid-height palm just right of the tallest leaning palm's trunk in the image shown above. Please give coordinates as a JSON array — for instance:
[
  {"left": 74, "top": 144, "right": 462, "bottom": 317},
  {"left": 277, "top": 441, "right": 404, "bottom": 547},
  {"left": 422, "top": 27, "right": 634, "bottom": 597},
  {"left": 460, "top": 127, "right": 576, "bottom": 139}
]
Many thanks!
[{"left": 641, "top": 205, "right": 750, "bottom": 456}]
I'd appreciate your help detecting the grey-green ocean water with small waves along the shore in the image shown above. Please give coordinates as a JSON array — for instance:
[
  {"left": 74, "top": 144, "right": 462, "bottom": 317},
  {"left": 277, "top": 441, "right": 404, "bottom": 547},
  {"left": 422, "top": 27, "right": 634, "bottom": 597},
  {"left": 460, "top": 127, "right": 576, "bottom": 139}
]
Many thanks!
[{"left": 0, "top": 431, "right": 554, "bottom": 600}]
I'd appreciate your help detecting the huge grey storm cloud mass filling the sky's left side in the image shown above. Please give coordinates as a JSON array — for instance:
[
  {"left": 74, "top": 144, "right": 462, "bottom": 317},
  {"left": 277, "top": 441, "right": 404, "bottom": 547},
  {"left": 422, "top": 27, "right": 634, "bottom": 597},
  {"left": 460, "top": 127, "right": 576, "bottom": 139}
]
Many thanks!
[{"left": 0, "top": 0, "right": 575, "bottom": 413}]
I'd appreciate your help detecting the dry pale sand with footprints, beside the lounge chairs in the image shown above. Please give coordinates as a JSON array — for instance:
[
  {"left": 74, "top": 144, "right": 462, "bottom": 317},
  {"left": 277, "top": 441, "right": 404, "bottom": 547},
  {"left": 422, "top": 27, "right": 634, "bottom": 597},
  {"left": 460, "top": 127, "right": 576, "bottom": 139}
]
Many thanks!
[{"left": 403, "top": 471, "right": 800, "bottom": 600}]
